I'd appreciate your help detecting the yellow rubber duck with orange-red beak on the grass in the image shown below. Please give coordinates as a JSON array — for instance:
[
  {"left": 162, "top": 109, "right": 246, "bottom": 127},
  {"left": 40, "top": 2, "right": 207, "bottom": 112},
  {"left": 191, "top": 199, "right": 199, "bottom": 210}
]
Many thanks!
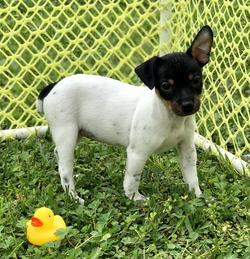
[{"left": 26, "top": 207, "right": 66, "bottom": 246}]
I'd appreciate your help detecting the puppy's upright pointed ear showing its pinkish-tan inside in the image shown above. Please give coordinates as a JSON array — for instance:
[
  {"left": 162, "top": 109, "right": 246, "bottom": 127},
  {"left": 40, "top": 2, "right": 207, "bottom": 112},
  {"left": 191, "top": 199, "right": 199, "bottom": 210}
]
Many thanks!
[{"left": 187, "top": 25, "right": 213, "bottom": 67}]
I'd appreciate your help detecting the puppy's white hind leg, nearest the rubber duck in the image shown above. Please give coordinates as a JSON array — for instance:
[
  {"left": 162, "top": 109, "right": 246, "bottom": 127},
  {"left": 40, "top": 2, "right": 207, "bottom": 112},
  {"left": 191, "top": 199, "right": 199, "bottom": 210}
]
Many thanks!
[{"left": 52, "top": 127, "right": 84, "bottom": 205}]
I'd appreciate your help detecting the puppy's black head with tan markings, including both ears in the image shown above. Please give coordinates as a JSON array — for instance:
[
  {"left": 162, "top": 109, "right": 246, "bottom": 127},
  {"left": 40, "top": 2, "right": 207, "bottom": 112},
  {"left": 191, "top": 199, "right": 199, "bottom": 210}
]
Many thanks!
[{"left": 135, "top": 26, "right": 213, "bottom": 116}]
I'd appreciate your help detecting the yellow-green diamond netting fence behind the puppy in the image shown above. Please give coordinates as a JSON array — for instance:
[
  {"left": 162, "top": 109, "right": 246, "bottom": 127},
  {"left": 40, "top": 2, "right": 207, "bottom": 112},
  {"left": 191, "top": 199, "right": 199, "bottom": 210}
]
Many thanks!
[{"left": 0, "top": 0, "right": 250, "bottom": 172}]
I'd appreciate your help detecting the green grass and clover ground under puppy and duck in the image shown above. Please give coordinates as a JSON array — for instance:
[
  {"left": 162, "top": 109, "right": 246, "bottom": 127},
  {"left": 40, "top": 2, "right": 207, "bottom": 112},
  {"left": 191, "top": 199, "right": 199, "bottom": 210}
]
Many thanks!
[{"left": 0, "top": 136, "right": 250, "bottom": 259}]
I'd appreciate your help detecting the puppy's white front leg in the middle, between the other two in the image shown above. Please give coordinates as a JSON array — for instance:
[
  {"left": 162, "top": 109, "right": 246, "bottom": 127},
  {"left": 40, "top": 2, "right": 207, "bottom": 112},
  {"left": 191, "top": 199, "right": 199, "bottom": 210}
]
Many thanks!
[{"left": 123, "top": 150, "right": 147, "bottom": 201}]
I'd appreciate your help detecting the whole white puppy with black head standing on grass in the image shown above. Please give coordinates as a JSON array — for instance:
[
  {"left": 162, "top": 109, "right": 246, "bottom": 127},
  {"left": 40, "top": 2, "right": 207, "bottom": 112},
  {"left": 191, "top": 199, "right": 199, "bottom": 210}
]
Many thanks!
[{"left": 36, "top": 26, "right": 213, "bottom": 204}]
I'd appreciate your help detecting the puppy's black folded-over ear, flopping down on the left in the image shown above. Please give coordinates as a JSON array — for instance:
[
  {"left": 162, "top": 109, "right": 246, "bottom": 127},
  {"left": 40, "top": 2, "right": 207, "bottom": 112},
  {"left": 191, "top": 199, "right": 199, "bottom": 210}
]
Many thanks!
[{"left": 135, "top": 56, "right": 163, "bottom": 90}]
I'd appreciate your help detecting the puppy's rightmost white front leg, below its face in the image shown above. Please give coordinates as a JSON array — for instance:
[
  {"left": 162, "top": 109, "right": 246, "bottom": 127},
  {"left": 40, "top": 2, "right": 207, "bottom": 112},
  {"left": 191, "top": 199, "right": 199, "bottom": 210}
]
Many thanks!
[{"left": 177, "top": 140, "right": 201, "bottom": 197}]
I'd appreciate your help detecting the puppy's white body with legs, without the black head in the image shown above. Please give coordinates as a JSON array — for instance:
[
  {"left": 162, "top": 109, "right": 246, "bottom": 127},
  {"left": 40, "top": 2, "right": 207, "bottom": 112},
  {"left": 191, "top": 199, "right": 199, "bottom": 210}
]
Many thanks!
[{"left": 37, "top": 75, "right": 201, "bottom": 203}]
